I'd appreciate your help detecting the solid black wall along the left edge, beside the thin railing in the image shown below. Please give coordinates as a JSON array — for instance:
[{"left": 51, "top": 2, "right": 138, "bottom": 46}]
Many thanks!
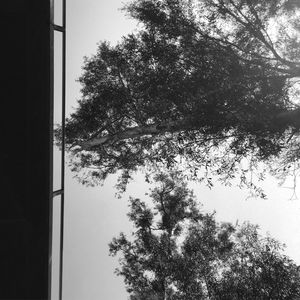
[{"left": 0, "top": 0, "right": 51, "bottom": 299}]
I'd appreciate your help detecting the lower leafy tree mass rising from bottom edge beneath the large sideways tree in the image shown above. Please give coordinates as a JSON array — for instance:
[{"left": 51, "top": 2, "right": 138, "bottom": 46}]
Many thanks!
[{"left": 109, "top": 174, "right": 300, "bottom": 300}]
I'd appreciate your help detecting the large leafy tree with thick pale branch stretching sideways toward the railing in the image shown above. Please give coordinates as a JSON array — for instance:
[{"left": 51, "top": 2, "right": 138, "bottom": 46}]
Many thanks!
[{"left": 61, "top": 0, "right": 300, "bottom": 188}]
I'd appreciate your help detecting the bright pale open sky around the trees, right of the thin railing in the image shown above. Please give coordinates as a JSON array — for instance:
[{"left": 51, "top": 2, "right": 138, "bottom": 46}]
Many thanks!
[{"left": 54, "top": 0, "right": 300, "bottom": 300}]
